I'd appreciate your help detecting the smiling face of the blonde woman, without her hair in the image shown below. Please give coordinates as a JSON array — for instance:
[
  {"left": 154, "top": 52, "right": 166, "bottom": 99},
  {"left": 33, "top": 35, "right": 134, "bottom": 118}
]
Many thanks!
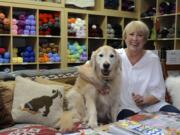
[{"left": 125, "top": 31, "right": 145, "bottom": 52}]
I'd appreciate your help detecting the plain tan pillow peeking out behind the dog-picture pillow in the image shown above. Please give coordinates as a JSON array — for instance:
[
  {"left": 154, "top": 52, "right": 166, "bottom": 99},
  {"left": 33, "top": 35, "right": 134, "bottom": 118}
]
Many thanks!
[{"left": 35, "top": 77, "right": 72, "bottom": 91}]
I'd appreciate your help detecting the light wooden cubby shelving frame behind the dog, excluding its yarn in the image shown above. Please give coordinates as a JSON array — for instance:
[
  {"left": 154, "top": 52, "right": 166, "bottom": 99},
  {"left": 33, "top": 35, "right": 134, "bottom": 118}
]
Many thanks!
[{"left": 0, "top": 0, "right": 139, "bottom": 72}]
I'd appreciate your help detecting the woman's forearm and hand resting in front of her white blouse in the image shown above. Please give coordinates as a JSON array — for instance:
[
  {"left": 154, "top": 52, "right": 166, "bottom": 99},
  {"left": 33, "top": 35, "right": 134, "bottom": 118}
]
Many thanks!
[{"left": 132, "top": 93, "right": 159, "bottom": 107}]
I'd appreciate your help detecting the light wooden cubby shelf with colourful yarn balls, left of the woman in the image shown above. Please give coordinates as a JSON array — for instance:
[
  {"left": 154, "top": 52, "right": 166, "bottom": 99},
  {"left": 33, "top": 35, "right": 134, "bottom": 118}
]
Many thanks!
[{"left": 0, "top": 0, "right": 138, "bottom": 72}]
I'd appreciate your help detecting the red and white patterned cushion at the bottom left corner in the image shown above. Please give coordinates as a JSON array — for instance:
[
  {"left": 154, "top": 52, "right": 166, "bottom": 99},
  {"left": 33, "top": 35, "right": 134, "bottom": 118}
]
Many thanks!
[{"left": 0, "top": 124, "right": 57, "bottom": 135}]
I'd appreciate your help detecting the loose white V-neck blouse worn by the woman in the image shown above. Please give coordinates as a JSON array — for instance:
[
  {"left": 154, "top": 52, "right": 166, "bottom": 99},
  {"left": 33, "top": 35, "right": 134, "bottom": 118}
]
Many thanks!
[{"left": 117, "top": 49, "right": 167, "bottom": 112}]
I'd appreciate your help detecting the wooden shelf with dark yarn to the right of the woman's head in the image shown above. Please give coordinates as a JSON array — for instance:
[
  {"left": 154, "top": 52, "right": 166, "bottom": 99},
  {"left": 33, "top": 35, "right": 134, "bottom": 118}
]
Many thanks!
[{"left": 139, "top": 0, "right": 180, "bottom": 67}]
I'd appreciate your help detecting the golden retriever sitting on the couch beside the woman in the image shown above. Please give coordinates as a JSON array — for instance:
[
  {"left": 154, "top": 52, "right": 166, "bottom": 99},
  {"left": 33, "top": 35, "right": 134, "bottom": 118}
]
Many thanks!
[{"left": 59, "top": 45, "right": 121, "bottom": 131}]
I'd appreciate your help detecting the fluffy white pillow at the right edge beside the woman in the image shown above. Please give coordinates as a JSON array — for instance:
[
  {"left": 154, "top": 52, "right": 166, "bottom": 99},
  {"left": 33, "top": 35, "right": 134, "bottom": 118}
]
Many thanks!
[{"left": 166, "top": 76, "right": 180, "bottom": 109}]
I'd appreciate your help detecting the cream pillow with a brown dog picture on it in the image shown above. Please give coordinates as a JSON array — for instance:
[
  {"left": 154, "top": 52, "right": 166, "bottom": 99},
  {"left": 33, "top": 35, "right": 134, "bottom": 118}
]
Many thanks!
[{"left": 12, "top": 76, "right": 64, "bottom": 128}]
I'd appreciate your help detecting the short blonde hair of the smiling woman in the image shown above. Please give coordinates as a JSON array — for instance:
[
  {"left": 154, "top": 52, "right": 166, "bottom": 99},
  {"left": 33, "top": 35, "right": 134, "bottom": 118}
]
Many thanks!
[{"left": 123, "top": 21, "right": 149, "bottom": 40}]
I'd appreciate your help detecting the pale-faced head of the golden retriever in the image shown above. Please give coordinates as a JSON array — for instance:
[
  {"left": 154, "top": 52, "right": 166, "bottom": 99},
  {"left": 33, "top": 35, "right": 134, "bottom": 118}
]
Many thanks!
[{"left": 90, "top": 45, "right": 121, "bottom": 78}]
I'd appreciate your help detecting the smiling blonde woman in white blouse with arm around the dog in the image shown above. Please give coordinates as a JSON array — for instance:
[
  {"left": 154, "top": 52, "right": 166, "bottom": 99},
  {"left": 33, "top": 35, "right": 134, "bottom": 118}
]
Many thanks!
[{"left": 79, "top": 21, "right": 180, "bottom": 120}]
